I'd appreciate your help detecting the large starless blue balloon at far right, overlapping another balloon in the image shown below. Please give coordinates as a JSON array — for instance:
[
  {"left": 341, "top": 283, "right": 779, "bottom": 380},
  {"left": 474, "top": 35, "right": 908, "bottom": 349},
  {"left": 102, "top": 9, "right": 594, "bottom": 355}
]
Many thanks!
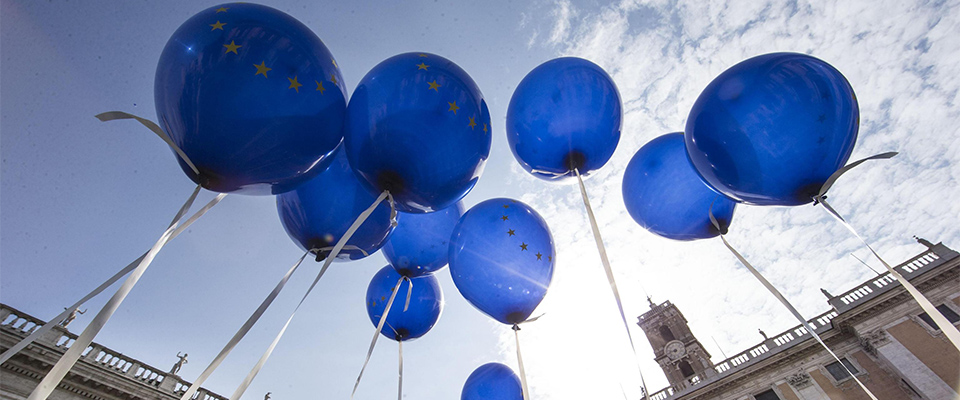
[{"left": 685, "top": 53, "right": 860, "bottom": 206}]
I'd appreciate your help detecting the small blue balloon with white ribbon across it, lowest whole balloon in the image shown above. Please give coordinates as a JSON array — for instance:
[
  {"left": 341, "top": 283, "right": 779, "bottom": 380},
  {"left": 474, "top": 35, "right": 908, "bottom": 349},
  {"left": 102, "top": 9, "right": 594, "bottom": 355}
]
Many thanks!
[{"left": 367, "top": 265, "right": 443, "bottom": 342}]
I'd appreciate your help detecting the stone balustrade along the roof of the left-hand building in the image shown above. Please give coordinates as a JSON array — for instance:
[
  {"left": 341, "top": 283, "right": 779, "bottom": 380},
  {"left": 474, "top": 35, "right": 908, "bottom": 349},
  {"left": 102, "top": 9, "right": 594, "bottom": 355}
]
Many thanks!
[{"left": 0, "top": 303, "right": 227, "bottom": 400}]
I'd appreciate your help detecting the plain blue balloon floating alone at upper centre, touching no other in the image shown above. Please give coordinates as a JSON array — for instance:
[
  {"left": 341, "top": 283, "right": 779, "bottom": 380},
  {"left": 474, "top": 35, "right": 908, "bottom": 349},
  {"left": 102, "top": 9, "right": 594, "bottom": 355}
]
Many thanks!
[{"left": 507, "top": 57, "right": 623, "bottom": 180}]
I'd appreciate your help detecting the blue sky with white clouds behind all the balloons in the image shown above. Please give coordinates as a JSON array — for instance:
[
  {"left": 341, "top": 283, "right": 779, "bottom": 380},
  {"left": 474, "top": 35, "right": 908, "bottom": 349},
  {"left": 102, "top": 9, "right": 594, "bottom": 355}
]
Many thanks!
[{"left": 0, "top": 0, "right": 960, "bottom": 400}]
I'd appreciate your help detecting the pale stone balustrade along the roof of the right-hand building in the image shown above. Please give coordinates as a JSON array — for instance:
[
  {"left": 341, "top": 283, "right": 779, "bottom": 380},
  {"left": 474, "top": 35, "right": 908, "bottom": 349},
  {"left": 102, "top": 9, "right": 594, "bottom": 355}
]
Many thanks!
[{"left": 650, "top": 243, "right": 960, "bottom": 400}]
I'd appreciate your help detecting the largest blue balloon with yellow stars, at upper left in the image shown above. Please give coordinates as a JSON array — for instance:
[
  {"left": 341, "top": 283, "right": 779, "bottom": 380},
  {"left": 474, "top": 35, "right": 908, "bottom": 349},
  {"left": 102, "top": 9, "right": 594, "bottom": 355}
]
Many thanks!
[{"left": 154, "top": 3, "right": 346, "bottom": 195}]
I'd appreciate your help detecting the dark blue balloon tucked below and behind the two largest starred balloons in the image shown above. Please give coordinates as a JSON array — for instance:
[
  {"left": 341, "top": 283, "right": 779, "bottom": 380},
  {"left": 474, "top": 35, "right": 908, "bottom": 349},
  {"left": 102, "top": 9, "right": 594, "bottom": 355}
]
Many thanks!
[{"left": 277, "top": 152, "right": 393, "bottom": 261}]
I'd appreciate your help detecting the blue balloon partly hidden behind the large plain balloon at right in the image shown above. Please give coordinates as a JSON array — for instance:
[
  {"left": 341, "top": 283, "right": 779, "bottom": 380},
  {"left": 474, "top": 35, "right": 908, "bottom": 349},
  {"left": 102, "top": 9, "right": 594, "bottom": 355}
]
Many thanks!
[{"left": 623, "top": 132, "right": 736, "bottom": 240}]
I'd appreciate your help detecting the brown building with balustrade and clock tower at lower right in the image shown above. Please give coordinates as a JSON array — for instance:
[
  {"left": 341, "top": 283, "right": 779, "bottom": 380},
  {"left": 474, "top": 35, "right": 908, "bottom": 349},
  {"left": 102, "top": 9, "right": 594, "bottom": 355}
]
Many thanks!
[{"left": 638, "top": 239, "right": 960, "bottom": 400}]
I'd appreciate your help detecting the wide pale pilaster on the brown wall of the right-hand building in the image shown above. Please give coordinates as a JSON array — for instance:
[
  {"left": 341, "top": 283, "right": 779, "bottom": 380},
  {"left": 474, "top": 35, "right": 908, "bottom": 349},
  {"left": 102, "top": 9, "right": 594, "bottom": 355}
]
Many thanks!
[{"left": 860, "top": 329, "right": 960, "bottom": 399}]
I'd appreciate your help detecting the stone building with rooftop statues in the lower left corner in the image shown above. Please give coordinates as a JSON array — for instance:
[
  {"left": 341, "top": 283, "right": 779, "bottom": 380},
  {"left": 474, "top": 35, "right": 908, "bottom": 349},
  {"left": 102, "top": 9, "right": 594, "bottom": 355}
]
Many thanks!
[{"left": 0, "top": 304, "right": 226, "bottom": 400}]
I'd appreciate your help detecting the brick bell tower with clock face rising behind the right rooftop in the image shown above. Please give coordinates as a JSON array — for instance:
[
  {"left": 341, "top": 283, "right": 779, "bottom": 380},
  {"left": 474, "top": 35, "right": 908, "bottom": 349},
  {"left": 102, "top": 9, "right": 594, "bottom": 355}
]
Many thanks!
[{"left": 637, "top": 297, "right": 715, "bottom": 387}]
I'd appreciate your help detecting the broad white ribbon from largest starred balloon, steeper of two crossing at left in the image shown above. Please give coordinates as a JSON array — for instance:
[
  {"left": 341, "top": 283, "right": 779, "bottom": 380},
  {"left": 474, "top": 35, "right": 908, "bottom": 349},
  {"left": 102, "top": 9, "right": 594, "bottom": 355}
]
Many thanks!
[{"left": 28, "top": 185, "right": 200, "bottom": 400}]
